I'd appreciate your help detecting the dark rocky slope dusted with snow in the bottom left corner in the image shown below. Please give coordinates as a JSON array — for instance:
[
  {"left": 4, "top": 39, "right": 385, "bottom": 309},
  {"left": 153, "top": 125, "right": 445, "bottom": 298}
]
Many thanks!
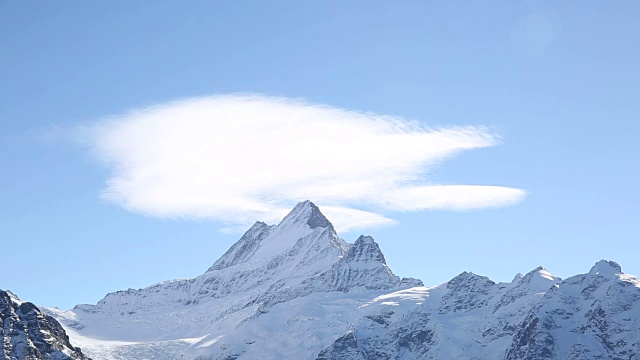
[{"left": 0, "top": 290, "right": 88, "bottom": 360}]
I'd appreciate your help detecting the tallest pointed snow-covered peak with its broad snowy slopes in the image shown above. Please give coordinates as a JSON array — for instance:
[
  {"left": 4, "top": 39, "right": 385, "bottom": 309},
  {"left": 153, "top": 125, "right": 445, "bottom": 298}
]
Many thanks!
[{"left": 49, "top": 201, "right": 422, "bottom": 359}]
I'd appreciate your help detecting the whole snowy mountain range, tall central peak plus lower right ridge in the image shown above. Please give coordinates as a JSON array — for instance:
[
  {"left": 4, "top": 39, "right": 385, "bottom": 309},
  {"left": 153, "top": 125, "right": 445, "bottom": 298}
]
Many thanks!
[{"left": 47, "top": 201, "right": 640, "bottom": 360}]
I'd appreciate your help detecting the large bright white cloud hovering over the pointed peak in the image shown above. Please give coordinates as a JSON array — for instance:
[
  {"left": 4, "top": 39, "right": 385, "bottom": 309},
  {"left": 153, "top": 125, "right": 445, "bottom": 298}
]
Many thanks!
[{"left": 82, "top": 95, "right": 525, "bottom": 231}]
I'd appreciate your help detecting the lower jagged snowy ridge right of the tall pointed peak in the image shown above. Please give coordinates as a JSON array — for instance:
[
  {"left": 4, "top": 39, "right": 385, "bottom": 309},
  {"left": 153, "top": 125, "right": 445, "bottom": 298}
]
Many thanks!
[{"left": 317, "top": 260, "right": 640, "bottom": 360}]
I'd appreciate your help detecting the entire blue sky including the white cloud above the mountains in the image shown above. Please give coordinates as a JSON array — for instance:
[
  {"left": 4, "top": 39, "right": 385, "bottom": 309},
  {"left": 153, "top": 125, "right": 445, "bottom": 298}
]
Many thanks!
[{"left": 0, "top": 1, "right": 640, "bottom": 308}]
